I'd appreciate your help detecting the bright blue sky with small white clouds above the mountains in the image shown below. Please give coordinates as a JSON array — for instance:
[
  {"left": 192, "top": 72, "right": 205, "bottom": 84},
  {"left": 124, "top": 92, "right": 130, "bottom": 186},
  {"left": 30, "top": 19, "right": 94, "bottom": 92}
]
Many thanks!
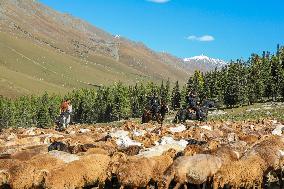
[{"left": 39, "top": 0, "right": 284, "bottom": 60}]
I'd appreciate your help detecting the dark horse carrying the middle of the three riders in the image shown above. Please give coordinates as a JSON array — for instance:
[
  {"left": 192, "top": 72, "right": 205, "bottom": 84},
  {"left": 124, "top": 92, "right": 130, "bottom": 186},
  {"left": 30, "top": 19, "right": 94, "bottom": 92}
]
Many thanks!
[{"left": 142, "top": 103, "right": 169, "bottom": 124}]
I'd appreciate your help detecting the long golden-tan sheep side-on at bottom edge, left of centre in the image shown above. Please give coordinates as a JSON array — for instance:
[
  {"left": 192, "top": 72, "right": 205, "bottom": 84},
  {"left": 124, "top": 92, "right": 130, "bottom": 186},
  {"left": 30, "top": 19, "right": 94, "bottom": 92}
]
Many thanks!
[{"left": 44, "top": 154, "right": 110, "bottom": 189}]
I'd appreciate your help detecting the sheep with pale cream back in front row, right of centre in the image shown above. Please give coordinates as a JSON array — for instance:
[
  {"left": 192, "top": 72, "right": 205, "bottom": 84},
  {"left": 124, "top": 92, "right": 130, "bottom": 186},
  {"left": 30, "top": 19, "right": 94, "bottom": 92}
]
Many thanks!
[{"left": 160, "top": 154, "right": 222, "bottom": 189}]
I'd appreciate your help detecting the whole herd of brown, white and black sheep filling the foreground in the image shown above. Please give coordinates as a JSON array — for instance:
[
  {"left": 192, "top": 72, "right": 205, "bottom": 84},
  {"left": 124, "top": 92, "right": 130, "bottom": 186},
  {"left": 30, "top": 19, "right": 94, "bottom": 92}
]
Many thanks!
[{"left": 0, "top": 120, "right": 284, "bottom": 189}]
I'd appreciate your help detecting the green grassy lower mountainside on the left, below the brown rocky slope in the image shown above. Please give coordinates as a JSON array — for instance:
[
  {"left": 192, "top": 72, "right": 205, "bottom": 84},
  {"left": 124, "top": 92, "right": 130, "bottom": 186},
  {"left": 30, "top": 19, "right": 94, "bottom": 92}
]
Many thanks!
[{"left": 0, "top": 32, "right": 150, "bottom": 96}]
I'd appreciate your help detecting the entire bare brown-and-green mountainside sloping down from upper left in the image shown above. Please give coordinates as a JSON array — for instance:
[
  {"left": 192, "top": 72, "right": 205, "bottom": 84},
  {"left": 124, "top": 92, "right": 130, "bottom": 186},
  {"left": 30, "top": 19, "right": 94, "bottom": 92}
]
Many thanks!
[{"left": 0, "top": 0, "right": 223, "bottom": 96}]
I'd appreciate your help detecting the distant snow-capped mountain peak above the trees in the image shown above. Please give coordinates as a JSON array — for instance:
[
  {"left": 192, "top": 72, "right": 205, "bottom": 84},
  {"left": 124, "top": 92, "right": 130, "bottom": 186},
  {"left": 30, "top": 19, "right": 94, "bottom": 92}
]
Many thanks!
[{"left": 183, "top": 54, "right": 228, "bottom": 71}]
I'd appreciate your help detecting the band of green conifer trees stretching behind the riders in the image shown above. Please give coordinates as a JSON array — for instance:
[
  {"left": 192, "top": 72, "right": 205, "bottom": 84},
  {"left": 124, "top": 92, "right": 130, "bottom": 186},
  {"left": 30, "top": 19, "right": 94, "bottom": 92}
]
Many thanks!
[{"left": 0, "top": 45, "right": 284, "bottom": 128}]
